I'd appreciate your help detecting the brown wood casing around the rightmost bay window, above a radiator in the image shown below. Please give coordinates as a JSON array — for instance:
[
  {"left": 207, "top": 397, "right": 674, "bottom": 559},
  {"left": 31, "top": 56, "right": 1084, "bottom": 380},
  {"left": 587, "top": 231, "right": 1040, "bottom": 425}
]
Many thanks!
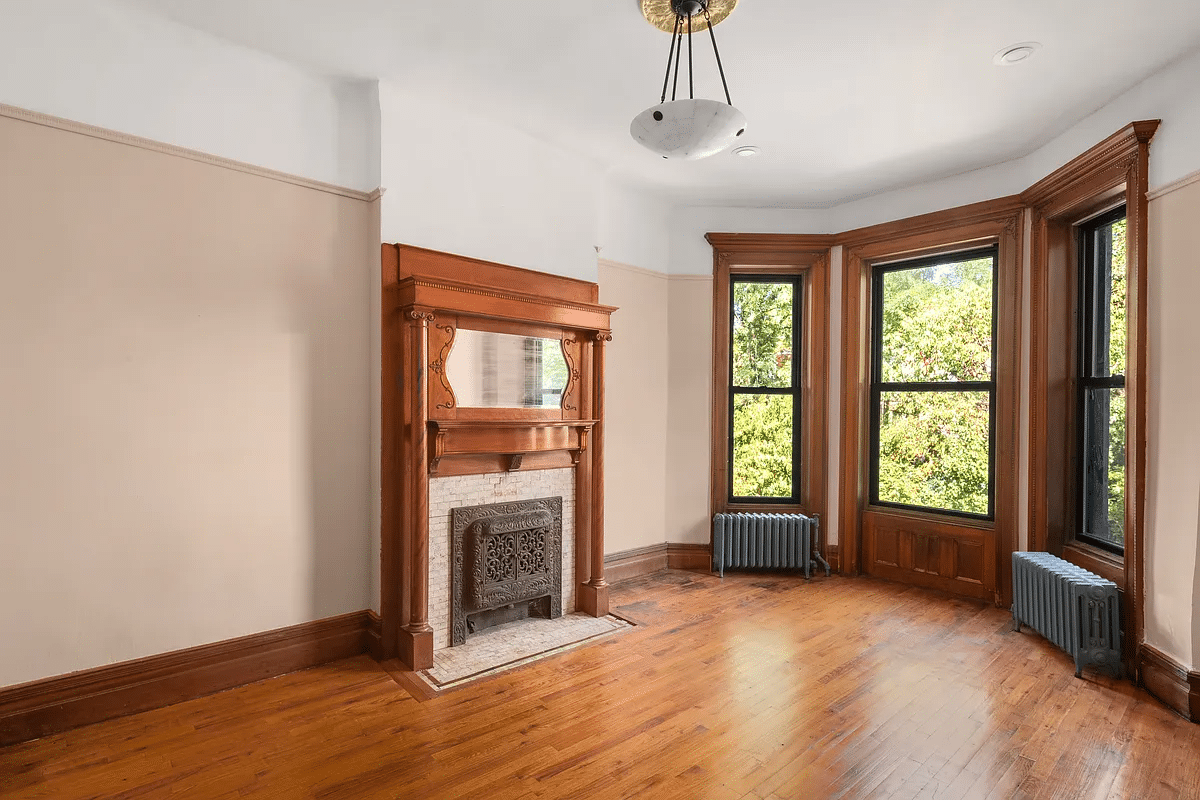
[{"left": 1021, "top": 120, "right": 1159, "bottom": 662}]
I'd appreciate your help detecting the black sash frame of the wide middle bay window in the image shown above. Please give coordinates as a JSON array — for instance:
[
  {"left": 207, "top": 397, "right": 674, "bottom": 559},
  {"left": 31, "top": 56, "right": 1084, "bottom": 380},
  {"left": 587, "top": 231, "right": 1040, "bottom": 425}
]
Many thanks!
[{"left": 868, "top": 245, "right": 1000, "bottom": 522}]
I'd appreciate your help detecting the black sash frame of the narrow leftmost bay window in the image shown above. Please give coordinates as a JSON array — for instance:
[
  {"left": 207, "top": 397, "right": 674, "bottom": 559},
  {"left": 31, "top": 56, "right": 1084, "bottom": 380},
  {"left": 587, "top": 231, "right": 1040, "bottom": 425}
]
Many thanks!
[{"left": 725, "top": 272, "right": 805, "bottom": 505}]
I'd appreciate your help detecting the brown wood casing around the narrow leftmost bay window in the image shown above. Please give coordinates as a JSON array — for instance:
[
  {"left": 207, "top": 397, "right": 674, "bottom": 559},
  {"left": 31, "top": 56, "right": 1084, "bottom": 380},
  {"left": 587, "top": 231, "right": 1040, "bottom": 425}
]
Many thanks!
[{"left": 707, "top": 233, "right": 832, "bottom": 515}]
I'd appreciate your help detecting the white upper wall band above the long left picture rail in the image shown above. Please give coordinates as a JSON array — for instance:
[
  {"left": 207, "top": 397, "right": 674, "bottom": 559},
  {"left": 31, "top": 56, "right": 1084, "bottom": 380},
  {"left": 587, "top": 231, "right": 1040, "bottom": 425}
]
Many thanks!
[{"left": 0, "top": 0, "right": 379, "bottom": 192}]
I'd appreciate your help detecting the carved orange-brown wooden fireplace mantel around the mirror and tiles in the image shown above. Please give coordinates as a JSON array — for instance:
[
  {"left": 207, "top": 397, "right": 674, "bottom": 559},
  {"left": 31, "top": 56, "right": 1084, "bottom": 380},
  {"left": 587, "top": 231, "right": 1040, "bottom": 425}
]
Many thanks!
[{"left": 380, "top": 245, "right": 616, "bottom": 669}]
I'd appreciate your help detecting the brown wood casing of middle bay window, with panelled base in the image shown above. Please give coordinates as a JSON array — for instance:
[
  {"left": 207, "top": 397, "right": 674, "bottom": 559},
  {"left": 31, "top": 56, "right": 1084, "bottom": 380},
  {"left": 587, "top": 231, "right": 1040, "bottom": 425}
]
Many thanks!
[{"left": 838, "top": 197, "right": 1022, "bottom": 603}]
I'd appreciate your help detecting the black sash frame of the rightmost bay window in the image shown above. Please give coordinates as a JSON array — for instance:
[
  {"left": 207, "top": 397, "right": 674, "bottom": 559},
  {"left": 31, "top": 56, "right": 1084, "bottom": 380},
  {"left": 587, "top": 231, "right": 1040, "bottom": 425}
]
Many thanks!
[{"left": 1074, "top": 203, "right": 1129, "bottom": 555}]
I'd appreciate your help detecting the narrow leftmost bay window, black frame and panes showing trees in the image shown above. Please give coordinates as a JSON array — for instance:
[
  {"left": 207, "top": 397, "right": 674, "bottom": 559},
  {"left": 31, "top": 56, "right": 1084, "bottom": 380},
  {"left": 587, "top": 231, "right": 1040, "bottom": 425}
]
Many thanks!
[{"left": 727, "top": 275, "right": 803, "bottom": 503}]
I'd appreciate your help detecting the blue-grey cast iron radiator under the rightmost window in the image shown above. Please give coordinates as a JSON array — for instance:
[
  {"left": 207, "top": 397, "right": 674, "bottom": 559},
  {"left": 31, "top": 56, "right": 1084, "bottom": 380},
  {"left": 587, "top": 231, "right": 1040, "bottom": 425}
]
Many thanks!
[{"left": 1013, "top": 553, "right": 1121, "bottom": 678}]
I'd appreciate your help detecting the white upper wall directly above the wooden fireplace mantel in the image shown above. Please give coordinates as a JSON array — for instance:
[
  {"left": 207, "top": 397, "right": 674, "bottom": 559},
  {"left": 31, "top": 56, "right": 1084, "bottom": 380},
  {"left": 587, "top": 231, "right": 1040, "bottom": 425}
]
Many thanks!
[{"left": 379, "top": 82, "right": 668, "bottom": 281}]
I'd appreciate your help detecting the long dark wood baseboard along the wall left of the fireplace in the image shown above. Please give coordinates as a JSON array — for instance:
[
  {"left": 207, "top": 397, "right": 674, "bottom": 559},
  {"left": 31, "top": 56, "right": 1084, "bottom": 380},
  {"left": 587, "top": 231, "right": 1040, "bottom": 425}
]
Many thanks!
[{"left": 0, "top": 610, "right": 379, "bottom": 746}]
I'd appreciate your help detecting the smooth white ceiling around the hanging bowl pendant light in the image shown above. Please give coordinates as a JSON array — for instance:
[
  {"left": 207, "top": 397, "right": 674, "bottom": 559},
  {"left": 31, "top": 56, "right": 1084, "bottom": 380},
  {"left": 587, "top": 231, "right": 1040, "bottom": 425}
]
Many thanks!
[{"left": 117, "top": 0, "right": 1200, "bottom": 207}]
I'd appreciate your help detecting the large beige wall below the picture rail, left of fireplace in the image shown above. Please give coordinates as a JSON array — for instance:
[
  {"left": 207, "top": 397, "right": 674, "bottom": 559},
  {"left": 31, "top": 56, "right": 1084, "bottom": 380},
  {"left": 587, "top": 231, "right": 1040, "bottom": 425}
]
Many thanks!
[{"left": 0, "top": 112, "right": 378, "bottom": 685}]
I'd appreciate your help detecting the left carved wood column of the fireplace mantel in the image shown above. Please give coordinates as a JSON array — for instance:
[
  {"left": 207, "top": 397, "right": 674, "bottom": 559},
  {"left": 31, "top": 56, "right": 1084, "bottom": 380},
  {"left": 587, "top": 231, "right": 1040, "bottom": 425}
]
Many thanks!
[{"left": 400, "top": 309, "right": 433, "bottom": 669}]
